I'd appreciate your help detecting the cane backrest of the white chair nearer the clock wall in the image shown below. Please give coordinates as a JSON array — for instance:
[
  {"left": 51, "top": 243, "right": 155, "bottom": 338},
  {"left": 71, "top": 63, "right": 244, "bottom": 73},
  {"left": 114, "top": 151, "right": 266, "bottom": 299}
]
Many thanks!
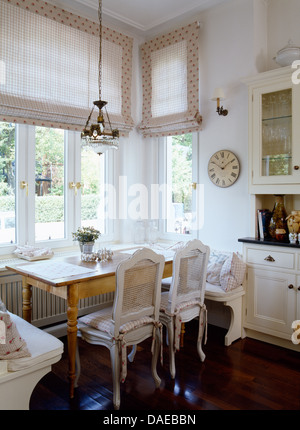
[{"left": 168, "top": 239, "right": 210, "bottom": 313}]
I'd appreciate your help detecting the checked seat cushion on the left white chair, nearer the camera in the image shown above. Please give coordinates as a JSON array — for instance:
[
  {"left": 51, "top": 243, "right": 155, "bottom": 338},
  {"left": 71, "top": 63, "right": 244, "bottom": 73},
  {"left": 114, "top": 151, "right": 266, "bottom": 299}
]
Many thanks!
[{"left": 78, "top": 307, "right": 154, "bottom": 336}]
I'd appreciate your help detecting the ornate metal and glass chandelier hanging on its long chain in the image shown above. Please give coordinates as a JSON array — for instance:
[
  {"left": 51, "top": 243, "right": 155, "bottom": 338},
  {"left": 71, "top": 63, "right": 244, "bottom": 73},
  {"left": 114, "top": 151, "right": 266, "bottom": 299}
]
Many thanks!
[{"left": 81, "top": 0, "right": 119, "bottom": 154}]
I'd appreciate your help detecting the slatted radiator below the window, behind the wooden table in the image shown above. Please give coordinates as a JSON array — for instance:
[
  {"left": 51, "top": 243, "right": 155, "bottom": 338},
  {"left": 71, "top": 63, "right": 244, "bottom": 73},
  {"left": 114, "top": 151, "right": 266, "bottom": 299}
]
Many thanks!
[{"left": 0, "top": 272, "right": 114, "bottom": 327}]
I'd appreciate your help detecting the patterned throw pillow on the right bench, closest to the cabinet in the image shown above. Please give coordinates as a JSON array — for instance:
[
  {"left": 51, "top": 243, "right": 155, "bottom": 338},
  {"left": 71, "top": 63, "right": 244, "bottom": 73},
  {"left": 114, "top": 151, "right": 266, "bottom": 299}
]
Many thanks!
[{"left": 220, "top": 252, "right": 246, "bottom": 291}]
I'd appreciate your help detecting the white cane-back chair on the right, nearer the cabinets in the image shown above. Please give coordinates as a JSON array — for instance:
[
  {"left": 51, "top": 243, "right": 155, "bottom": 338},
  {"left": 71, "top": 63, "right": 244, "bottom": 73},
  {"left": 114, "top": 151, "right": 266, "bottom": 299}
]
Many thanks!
[{"left": 160, "top": 239, "right": 210, "bottom": 379}]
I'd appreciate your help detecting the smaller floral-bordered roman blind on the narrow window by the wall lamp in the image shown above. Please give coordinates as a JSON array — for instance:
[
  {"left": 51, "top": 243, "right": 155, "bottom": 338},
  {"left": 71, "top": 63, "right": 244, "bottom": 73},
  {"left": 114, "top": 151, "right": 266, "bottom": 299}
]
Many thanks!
[{"left": 139, "top": 23, "right": 202, "bottom": 137}]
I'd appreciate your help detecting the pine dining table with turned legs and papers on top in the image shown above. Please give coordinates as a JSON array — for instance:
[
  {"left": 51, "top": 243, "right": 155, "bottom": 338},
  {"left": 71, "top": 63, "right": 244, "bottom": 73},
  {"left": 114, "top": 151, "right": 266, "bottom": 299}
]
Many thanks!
[{"left": 6, "top": 250, "right": 173, "bottom": 398}]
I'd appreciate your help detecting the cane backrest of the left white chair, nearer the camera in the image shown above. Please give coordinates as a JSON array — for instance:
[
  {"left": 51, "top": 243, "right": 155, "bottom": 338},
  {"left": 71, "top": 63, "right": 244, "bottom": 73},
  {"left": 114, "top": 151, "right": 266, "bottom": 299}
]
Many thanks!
[{"left": 112, "top": 248, "right": 165, "bottom": 333}]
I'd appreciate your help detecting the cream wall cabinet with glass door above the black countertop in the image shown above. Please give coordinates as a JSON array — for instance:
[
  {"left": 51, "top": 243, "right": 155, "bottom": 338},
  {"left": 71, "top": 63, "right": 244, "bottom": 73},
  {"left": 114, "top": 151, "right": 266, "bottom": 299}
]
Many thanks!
[{"left": 243, "top": 67, "right": 300, "bottom": 194}]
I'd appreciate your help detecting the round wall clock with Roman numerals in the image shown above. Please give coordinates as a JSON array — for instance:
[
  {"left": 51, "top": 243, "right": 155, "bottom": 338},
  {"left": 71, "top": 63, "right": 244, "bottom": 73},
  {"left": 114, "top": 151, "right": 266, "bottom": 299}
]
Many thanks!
[{"left": 208, "top": 149, "right": 240, "bottom": 188}]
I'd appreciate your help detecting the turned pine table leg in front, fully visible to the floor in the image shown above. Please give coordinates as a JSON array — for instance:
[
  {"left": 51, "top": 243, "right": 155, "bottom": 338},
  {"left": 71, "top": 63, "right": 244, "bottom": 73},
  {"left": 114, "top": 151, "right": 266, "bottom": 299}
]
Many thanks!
[{"left": 67, "top": 284, "right": 78, "bottom": 399}]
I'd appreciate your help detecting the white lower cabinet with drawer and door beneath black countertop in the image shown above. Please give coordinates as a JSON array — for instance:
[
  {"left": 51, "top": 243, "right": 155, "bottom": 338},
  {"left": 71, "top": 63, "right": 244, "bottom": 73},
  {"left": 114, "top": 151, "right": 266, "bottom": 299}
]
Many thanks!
[{"left": 240, "top": 239, "right": 300, "bottom": 350}]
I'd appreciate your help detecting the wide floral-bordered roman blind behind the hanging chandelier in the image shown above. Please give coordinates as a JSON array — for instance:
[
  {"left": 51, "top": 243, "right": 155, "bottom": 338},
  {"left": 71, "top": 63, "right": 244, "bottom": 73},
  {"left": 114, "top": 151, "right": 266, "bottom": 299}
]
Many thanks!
[{"left": 0, "top": 0, "right": 133, "bottom": 135}]
